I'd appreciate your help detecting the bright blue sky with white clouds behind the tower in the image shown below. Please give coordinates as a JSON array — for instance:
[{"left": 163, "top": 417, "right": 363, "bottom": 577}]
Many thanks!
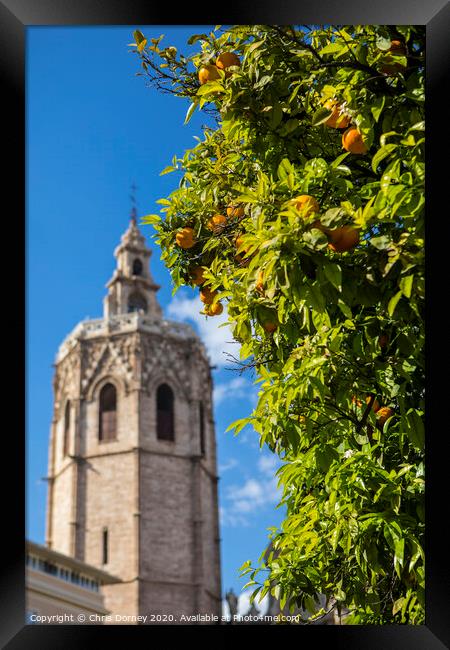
[{"left": 26, "top": 25, "right": 282, "bottom": 604}]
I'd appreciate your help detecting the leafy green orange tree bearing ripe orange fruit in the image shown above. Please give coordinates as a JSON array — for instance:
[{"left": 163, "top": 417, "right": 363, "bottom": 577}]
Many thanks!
[{"left": 134, "top": 25, "right": 424, "bottom": 624}]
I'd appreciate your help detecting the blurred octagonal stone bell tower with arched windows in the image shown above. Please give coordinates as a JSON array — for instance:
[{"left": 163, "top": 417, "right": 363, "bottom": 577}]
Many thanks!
[{"left": 46, "top": 211, "right": 221, "bottom": 622}]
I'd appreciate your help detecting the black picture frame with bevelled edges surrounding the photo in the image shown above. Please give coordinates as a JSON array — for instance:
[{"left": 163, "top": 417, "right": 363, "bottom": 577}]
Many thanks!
[{"left": 0, "top": 0, "right": 450, "bottom": 650}]
